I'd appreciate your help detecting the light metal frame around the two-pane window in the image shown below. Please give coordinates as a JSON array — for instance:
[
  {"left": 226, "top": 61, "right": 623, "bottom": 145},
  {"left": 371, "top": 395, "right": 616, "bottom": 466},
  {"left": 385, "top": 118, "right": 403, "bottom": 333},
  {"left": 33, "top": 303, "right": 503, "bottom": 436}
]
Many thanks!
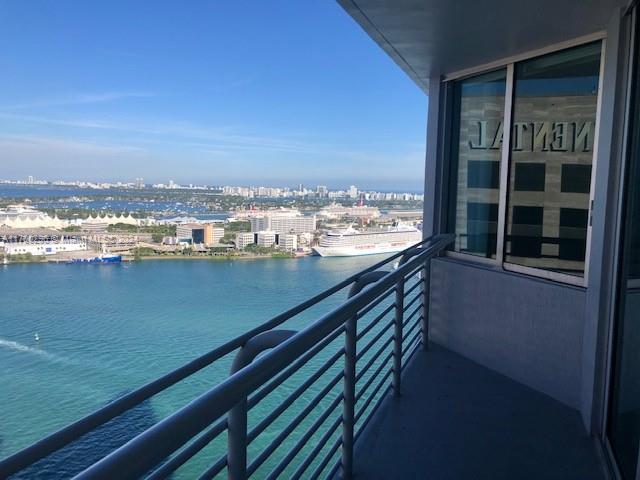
[{"left": 441, "top": 31, "right": 607, "bottom": 288}]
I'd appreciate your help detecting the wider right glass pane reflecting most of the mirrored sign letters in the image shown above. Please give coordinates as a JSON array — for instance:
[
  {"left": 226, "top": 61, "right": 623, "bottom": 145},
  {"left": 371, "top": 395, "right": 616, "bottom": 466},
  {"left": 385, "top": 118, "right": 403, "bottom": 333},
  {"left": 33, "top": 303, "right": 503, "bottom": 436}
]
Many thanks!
[{"left": 505, "top": 42, "right": 601, "bottom": 276}]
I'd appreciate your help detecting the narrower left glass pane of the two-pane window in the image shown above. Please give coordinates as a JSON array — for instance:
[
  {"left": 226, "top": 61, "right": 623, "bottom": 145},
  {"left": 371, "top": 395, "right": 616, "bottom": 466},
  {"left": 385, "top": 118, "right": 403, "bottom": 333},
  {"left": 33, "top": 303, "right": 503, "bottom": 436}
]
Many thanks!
[{"left": 449, "top": 69, "right": 506, "bottom": 258}]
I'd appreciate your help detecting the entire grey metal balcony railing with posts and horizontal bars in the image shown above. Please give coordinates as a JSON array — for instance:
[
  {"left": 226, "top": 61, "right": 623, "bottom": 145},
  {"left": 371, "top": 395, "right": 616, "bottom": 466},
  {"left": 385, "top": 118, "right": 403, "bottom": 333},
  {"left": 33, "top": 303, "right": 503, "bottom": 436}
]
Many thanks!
[{"left": 0, "top": 235, "right": 453, "bottom": 479}]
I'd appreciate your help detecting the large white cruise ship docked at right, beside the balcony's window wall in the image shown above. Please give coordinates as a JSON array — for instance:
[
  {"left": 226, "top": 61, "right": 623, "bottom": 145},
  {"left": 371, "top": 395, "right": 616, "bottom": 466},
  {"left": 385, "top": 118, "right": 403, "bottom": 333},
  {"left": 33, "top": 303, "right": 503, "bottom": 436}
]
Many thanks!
[{"left": 313, "top": 225, "right": 422, "bottom": 257}]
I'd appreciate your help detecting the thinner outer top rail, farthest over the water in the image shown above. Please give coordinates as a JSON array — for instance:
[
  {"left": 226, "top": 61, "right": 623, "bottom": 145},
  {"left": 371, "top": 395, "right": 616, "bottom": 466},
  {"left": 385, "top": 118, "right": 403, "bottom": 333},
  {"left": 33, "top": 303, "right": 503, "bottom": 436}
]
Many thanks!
[{"left": 0, "top": 236, "right": 442, "bottom": 478}]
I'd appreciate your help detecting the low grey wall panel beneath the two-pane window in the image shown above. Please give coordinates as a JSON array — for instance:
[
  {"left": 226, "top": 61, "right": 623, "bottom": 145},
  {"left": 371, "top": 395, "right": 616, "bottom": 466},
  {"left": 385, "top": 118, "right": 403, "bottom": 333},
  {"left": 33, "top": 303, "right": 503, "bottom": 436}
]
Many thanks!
[{"left": 429, "top": 258, "right": 585, "bottom": 409}]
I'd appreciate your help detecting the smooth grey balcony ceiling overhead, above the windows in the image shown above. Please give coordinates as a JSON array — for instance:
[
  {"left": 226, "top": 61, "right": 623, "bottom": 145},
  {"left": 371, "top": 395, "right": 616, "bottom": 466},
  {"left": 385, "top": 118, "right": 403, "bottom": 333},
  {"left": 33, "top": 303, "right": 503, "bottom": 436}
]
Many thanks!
[{"left": 338, "top": 0, "right": 628, "bottom": 92}]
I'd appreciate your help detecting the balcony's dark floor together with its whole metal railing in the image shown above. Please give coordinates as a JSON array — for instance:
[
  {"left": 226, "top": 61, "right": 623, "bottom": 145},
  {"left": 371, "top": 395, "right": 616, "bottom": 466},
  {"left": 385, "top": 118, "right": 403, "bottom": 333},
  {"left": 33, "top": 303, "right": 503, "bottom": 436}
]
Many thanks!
[{"left": 0, "top": 235, "right": 602, "bottom": 479}]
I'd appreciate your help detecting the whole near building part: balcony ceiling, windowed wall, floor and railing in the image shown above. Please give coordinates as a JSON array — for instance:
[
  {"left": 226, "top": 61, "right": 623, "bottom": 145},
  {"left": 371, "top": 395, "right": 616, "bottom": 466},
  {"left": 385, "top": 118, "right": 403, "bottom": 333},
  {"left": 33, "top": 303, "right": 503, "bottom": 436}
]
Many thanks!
[{"left": 6, "top": 0, "right": 640, "bottom": 480}]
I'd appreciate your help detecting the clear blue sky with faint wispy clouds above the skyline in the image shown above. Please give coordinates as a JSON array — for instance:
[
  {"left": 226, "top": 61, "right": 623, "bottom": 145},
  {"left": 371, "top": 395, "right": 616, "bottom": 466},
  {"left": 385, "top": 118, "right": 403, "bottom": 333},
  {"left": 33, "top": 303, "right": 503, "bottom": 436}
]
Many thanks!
[{"left": 0, "top": 0, "right": 427, "bottom": 189}]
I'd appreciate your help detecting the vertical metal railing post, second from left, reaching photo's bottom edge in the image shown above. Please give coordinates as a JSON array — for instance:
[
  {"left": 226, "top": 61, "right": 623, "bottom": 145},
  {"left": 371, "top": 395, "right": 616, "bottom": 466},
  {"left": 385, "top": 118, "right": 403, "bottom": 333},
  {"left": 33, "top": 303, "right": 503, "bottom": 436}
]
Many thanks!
[{"left": 341, "top": 316, "right": 357, "bottom": 479}]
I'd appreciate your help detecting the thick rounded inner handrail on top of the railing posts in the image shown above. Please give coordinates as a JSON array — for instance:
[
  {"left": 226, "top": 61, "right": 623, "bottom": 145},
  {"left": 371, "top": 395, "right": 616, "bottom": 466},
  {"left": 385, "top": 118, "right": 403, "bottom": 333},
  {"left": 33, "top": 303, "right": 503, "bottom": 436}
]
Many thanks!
[{"left": 72, "top": 234, "right": 455, "bottom": 480}]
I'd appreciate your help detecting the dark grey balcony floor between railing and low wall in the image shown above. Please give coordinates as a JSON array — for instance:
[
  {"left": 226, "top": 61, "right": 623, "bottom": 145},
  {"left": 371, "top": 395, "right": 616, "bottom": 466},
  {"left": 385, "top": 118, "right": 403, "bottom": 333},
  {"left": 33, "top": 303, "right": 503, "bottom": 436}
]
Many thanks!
[{"left": 354, "top": 347, "right": 605, "bottom": 480}]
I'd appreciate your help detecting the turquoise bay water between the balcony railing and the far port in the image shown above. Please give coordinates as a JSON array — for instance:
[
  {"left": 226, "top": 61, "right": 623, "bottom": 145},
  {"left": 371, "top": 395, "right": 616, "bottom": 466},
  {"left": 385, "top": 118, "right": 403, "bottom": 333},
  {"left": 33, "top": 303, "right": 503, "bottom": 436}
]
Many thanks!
[{"left": 0, "top": 256, "right": 380, "bottom": 478}]
